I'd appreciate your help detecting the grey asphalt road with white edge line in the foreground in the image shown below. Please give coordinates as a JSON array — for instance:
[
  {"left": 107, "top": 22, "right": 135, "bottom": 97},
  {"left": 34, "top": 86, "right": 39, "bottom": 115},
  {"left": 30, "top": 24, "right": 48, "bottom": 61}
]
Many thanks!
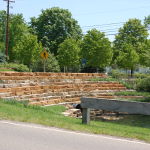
[{"left": 0, "top": 120, "right": 150, "bottom": 150}]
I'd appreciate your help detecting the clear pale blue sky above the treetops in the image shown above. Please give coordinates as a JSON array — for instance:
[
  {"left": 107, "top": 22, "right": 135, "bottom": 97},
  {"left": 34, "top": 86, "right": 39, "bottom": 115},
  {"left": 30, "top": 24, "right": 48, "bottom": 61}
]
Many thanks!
[{"left": 0, "top": 0, "right": 150, "bottom": 40}]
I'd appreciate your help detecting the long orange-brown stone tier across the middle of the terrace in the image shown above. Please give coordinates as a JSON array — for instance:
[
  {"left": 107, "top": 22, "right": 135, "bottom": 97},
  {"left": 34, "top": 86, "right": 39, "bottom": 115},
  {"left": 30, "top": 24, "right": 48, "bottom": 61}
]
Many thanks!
[{"left": 0, "top": 84, "right": 126, "bottom": 96}]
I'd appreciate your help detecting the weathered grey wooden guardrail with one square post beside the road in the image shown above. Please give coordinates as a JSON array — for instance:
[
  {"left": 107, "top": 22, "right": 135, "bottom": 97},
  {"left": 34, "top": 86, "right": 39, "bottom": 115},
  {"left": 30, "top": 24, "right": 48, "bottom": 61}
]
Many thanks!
[{"left": 81, "top": 98, "right": 150, "bottom": 124}]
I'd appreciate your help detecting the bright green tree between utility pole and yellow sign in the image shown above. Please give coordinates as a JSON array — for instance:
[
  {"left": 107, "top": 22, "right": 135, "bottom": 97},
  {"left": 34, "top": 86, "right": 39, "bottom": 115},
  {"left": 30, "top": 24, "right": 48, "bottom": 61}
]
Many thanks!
[{"left": 13, "top": 34, "right": 43, "bottom": 68}]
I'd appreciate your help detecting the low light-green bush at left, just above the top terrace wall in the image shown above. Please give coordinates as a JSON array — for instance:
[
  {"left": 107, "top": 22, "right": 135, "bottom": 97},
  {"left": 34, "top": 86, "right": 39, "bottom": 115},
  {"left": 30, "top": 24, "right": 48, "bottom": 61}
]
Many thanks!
[{"left": 0, "top": 63, "right": 30, "bottom": 72}]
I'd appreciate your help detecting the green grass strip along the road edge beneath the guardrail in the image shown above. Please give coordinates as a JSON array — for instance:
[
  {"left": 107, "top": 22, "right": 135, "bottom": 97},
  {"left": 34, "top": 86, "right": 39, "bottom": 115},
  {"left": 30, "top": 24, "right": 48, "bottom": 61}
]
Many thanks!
[{"left": 0, "top": 100, "right": 150, "bottom": 143}]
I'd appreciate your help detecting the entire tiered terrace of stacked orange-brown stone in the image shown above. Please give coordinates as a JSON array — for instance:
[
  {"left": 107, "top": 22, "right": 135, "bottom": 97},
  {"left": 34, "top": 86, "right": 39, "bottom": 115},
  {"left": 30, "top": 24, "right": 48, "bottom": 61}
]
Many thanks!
[{"left": 0, "top": 72, "right": 126, "bottom": 105}]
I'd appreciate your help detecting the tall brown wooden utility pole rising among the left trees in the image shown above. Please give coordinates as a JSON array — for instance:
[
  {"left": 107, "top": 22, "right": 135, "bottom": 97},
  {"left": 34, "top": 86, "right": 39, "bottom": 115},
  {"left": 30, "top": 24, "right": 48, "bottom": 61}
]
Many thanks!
[{"left": 4, "top": 0, "right": 15, "bottom": 59}]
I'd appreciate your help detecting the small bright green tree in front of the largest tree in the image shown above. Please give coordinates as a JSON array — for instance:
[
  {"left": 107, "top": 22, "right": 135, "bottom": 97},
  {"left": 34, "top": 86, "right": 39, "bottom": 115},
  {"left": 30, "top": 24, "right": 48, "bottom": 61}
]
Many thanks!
[{"left": 57, "top": 38, "right": 80, "bottom": 72}]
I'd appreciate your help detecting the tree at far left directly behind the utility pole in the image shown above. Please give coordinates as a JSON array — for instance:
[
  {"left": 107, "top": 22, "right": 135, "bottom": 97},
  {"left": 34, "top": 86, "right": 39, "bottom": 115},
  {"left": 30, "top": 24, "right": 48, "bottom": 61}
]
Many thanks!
[{"left": 0, "top": 11, "right": 29, "bottom": 61}]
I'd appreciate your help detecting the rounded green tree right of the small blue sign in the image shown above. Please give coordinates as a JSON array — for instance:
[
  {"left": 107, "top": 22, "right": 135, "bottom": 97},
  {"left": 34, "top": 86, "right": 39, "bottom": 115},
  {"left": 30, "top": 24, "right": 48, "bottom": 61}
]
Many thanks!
[{"left": 81, "top": 29, "right": 112, "bottom": 68}]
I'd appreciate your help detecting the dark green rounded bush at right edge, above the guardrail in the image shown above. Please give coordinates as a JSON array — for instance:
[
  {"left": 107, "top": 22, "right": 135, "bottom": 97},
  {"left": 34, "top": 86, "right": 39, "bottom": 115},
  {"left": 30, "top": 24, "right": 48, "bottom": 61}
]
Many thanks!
[{"left": 137, "top": 76, "right": 150, "bottom": 92}]
